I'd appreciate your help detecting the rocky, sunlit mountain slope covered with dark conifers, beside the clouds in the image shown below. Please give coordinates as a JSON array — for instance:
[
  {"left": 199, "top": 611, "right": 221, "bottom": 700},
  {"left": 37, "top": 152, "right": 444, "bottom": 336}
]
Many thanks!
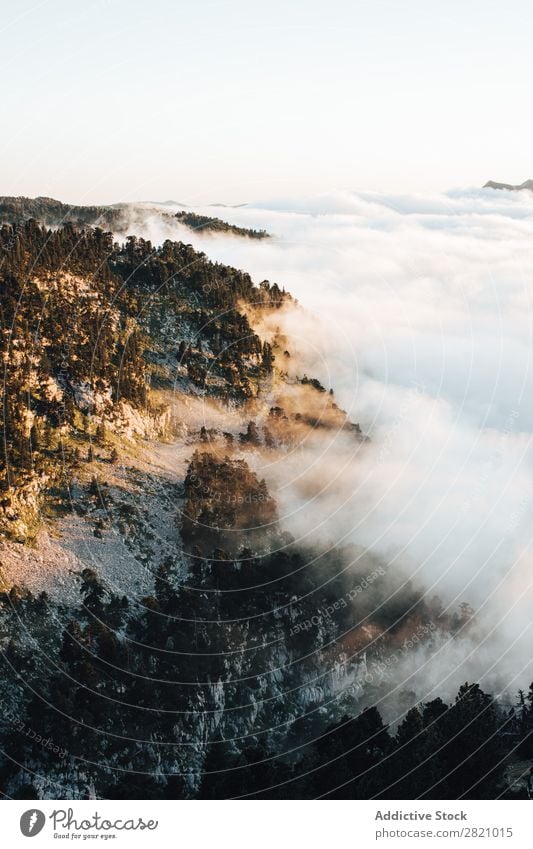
[{"left": 0, "top": 215, "right": 520, "bottom": 798}]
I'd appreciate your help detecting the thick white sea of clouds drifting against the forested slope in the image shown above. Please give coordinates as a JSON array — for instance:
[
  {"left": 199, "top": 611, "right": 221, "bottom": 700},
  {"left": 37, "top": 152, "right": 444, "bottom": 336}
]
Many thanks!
[{"left": 122, "top": 189, "right": 533, "bottom": 690}]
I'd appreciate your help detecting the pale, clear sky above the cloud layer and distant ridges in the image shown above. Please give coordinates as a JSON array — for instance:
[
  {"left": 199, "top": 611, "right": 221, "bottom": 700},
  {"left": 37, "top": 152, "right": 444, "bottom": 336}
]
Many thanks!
[{"left": 0, "top": 0, "right": 533, "bottom": 205}]
